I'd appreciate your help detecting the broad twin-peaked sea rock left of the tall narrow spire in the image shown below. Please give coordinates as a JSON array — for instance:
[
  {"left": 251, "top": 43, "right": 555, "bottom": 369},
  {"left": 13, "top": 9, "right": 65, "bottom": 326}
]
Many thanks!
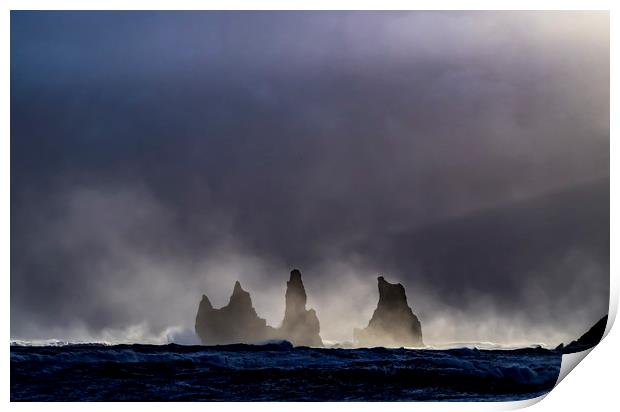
[{"left": 196, "top": 281, "right": 275, "bottom": 345}]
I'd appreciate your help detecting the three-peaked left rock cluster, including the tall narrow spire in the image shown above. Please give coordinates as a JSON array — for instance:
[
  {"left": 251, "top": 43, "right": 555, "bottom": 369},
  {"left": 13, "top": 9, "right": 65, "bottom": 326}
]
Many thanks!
[{"left": 195, "top": 269, "right": 323, "bottom": 346}]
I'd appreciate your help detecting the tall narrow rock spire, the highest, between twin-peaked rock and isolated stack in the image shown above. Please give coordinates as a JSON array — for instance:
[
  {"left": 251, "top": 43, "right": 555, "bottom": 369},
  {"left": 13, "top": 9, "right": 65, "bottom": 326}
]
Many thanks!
[{"left": 278, "top": 269, "right": 323, "bottom": 346}]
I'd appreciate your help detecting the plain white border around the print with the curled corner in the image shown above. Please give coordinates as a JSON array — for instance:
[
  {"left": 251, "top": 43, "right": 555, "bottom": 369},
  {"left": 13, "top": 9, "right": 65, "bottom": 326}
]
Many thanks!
[{"left": 0, "top": 0, "right": 620, "bottom": 412}]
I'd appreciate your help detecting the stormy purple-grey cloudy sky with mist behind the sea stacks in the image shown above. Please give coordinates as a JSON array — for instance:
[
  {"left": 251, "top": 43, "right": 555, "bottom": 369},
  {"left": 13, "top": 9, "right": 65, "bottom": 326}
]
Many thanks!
[{"left": 11, "top": 12, "right": 609, "bottom": 344}]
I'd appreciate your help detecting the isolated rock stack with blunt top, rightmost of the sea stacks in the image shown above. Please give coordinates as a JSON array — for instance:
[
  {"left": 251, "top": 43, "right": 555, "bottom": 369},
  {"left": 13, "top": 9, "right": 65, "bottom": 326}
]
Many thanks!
[{"left": 353, "top": 276, "right": 424, "bottom": 347}]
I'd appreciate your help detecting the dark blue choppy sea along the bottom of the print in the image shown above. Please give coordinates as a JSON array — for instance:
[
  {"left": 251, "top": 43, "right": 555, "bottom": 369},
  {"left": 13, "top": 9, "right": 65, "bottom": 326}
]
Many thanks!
[{"left": 11, "top": 342, "right": 561, "bottom": 401}]
